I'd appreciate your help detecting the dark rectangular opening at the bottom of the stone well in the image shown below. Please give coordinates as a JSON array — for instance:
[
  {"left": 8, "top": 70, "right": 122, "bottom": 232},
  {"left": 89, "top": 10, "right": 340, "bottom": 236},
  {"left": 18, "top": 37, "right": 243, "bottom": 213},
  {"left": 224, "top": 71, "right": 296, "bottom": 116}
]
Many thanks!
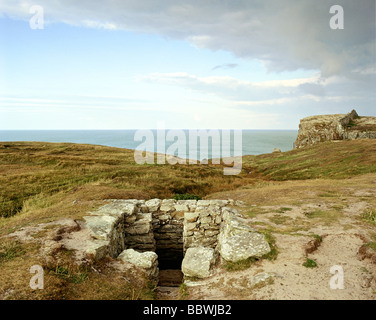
[{"left": 155, "top": 248, "right": 183, "bottom": 287}]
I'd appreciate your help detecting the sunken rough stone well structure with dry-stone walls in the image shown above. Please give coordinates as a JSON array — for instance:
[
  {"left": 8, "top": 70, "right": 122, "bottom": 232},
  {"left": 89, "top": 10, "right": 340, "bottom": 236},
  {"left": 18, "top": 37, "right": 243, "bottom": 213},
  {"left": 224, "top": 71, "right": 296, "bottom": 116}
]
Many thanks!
[{"left": 84, "top": 199, "right": 270, "bottom": 279}]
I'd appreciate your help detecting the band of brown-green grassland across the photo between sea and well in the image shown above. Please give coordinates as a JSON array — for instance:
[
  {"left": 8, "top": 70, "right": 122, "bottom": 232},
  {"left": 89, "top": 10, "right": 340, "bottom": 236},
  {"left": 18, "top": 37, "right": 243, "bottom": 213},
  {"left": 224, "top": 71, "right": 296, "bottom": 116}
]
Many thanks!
[{"left": 0, "top": 140, "right": 376, "bottom": 224}]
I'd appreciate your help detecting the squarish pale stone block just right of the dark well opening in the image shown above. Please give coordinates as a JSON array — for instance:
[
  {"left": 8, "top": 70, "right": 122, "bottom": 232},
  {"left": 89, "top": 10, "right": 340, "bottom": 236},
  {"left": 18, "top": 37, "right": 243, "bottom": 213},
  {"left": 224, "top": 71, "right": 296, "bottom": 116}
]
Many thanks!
[{"left": 182, "top": 247, "right": 216, "bottom": 278}]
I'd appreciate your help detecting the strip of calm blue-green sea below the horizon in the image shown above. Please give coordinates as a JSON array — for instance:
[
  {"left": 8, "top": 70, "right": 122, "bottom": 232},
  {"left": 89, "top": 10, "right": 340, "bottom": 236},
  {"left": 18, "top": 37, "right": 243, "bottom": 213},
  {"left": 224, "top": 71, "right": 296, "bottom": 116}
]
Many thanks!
[{"left": 0, "top": 129, "right": 298, "bottom": 160}]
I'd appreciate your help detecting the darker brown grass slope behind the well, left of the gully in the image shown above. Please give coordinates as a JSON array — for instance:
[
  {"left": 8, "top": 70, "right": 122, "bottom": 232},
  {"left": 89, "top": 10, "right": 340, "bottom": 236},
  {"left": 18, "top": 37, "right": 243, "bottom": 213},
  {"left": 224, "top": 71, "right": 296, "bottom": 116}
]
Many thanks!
[{"left": 0, "top": 142, "right": 256, "bottom": 217}]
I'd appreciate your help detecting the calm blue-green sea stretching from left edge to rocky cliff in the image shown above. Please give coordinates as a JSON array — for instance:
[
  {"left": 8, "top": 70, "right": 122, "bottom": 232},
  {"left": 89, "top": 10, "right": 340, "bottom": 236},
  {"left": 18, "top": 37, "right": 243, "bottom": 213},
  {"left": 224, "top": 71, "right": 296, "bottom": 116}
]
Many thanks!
[{"left": 0, "top": 129, "right": 298, "bottom": 160}]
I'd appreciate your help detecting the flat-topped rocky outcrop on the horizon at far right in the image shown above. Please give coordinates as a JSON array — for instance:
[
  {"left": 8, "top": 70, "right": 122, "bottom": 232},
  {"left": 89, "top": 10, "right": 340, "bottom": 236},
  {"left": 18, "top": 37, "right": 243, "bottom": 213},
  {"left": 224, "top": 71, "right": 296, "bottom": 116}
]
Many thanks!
[{"left": 294, "top": 110, "right": 376, "bottom": 148}]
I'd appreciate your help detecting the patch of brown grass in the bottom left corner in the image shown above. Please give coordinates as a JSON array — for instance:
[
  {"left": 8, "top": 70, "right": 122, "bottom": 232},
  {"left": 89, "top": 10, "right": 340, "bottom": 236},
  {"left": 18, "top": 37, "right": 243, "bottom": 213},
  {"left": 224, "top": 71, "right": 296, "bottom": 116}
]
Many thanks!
[{"left": 0, "top": 241, "right": 154, "bottom": 300}]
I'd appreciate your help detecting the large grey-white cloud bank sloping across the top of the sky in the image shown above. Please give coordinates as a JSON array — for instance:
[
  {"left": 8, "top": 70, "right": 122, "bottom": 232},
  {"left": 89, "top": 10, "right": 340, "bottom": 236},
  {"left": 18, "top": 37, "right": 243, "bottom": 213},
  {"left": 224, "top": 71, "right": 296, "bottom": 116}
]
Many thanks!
[{"left": 0, "top": 0, "right": 375, "bottom": 77}]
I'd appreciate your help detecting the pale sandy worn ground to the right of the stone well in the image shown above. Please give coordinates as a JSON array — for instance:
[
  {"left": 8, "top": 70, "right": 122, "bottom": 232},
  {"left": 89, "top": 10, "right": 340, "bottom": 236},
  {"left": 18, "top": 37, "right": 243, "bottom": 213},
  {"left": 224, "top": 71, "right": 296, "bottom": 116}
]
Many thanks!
[{"left": 187, "top": 175, "right": 376, "bottom": 300}]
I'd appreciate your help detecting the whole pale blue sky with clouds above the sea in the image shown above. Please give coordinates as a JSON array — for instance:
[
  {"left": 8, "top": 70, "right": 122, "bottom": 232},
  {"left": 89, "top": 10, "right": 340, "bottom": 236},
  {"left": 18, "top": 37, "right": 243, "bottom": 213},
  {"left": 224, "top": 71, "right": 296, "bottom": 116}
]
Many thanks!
[{"left": 0, "top": 0, "right": 376, "bottom": 130}]
